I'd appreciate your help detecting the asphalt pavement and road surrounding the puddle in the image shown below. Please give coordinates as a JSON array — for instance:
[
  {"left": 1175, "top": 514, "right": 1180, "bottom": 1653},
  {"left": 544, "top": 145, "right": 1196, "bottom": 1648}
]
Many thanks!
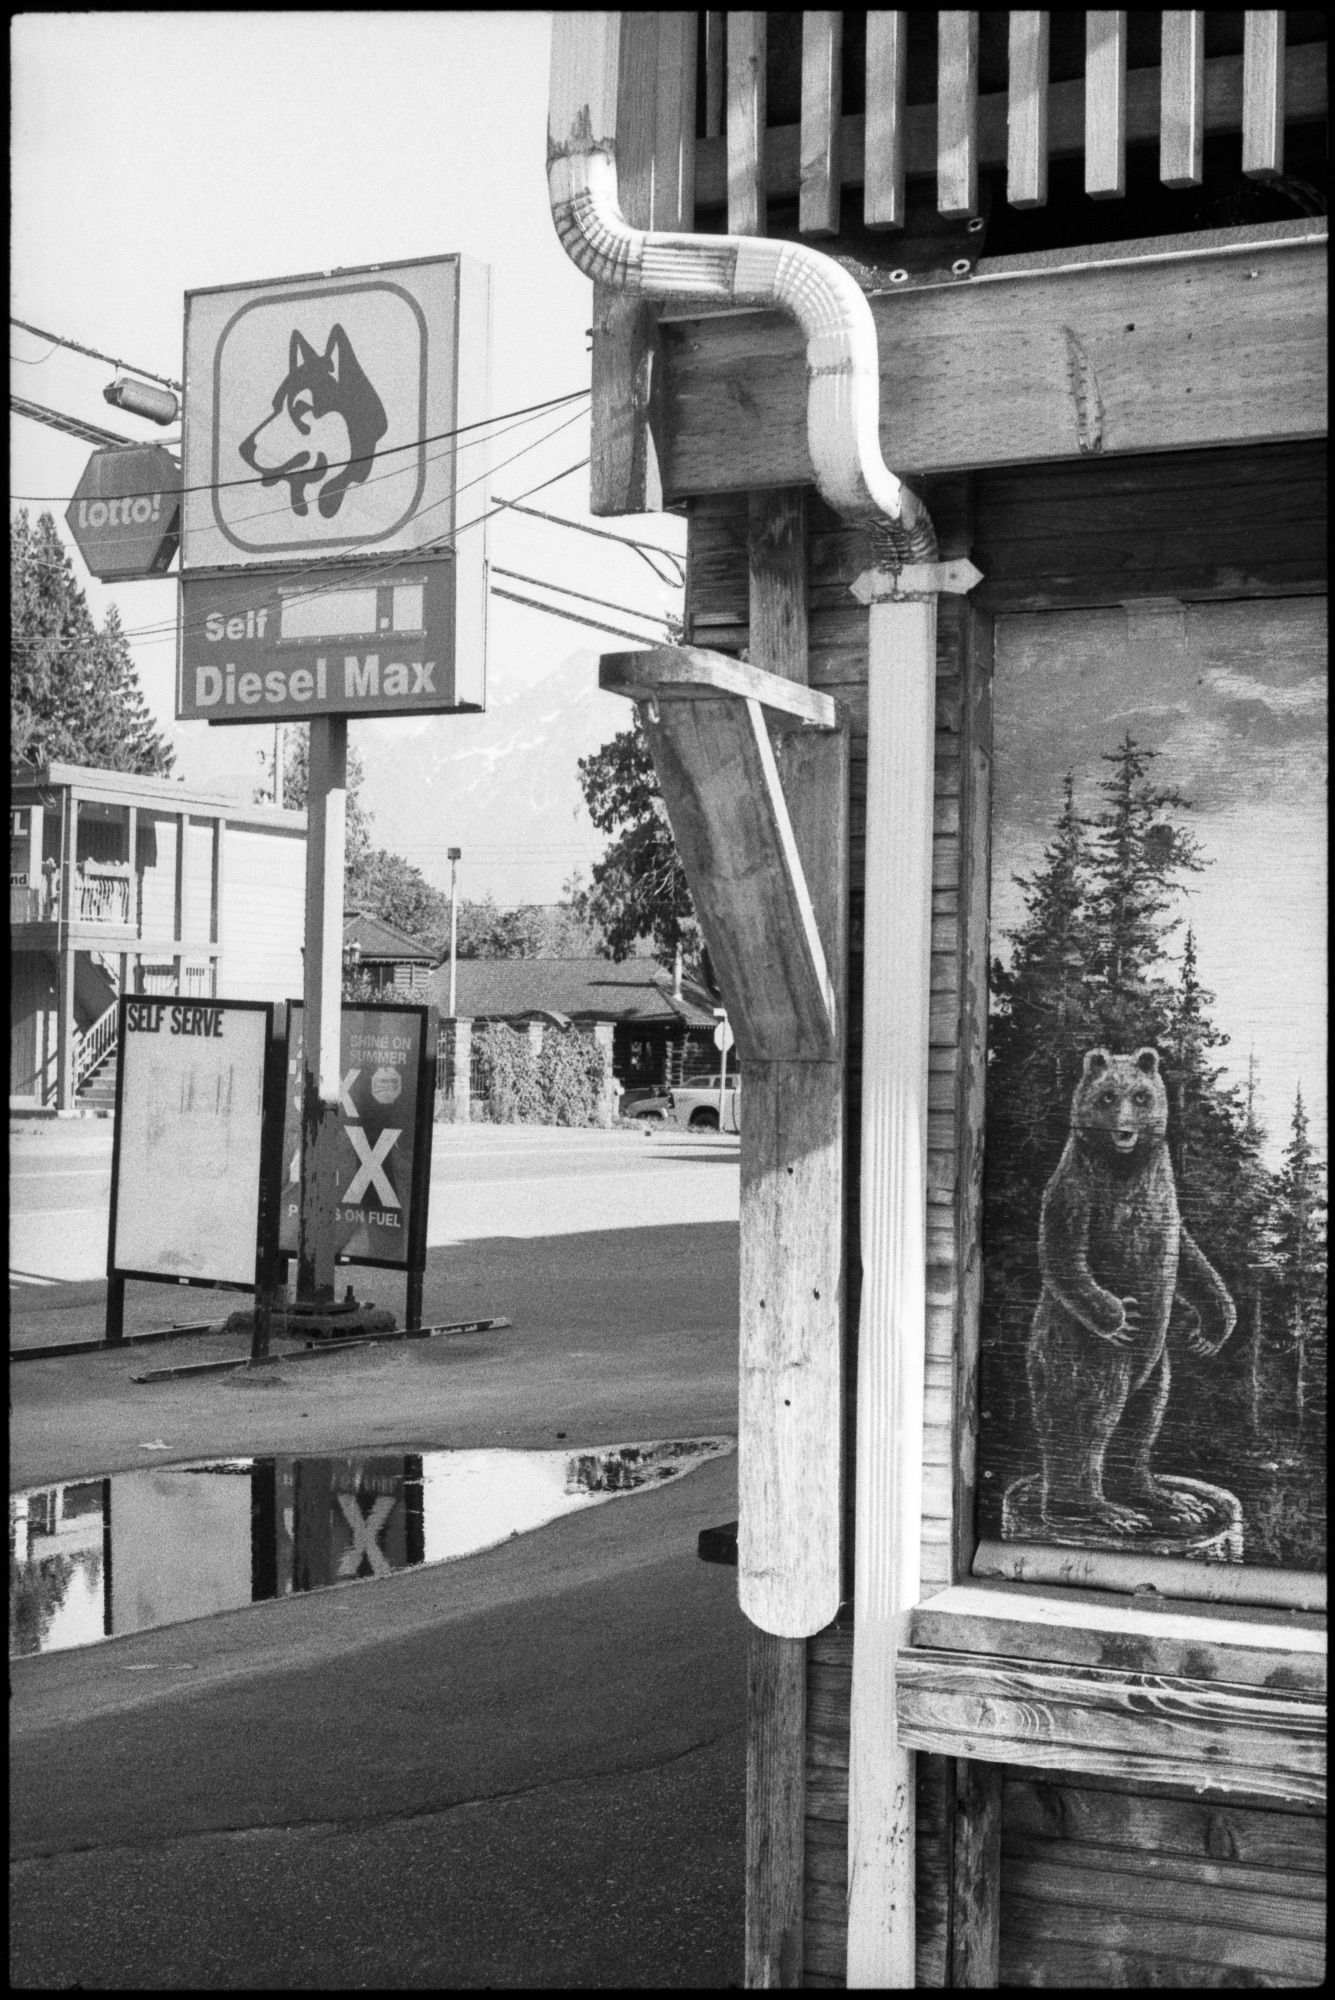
[{"left": 10, "top": 1128, "right": 745, "bottom": 1990}]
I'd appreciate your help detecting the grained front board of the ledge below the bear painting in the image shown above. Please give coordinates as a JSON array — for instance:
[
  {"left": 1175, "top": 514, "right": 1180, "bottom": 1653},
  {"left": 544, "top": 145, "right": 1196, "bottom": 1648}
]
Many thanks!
[{"left": 895, "top": 1646, "right": 1325, "bottom": 1806}]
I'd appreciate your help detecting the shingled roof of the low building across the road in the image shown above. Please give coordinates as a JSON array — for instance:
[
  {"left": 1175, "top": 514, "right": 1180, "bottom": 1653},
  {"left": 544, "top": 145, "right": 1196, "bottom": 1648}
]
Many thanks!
[{"left": 432, "top": 958, "right": 713, "bottom": 1028}]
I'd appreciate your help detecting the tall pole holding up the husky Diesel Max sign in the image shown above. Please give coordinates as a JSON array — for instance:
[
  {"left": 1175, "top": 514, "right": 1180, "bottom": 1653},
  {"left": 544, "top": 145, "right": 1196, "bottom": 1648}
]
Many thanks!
[{"left": 296, "top": 716, "right": 348, "bottom": 1306}]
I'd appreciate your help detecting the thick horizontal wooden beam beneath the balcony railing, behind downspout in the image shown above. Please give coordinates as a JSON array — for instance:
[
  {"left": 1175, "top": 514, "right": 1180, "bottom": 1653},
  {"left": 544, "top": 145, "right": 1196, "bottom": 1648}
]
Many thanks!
[{"left": 664, "top": 218, "right": 1327, "bottom": 498}]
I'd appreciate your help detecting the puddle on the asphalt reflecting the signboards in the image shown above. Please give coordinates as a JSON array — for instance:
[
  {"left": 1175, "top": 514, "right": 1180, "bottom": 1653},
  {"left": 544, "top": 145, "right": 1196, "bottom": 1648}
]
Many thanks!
[{"left": 10, "top": 1438, "right": 733, "bottom": 1660}]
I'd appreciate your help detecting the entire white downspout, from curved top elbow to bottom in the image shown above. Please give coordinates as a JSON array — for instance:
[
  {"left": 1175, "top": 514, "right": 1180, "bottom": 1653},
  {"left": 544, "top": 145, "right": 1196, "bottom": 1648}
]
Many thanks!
[{"left": 548, "top": 12, "right": 979, "bottom": 1988}]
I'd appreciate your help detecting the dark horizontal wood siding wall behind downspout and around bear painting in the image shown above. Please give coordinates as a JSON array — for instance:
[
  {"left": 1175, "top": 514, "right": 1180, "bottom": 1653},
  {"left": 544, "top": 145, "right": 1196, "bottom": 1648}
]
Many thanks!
[{"left": 687, "top": 446, "right": 1325, "bottom": 1986}]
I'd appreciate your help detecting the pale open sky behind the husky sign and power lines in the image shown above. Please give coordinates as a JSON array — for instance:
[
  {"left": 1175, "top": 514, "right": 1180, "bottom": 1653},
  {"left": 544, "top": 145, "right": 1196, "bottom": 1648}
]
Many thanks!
[{"left": 10, "top": 10, "right": 685, "bottom": 904}]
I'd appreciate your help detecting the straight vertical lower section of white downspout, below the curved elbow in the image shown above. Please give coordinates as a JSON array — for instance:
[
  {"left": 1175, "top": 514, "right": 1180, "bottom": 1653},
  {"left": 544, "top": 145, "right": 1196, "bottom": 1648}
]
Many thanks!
[{"left": 847, "top": 562, "right": 979, "bottom": 1986}]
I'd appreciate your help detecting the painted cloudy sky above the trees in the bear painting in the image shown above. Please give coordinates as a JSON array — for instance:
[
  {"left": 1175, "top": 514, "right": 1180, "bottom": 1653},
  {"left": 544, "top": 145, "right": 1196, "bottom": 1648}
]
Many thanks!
[{"left": 991, "top": 598, "right": 1329, "bottom": 1164}]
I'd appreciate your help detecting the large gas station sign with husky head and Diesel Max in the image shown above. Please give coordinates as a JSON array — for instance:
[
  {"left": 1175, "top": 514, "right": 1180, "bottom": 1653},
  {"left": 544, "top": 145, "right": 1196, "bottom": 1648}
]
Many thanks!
[{"left": 176, "top": 256, "right": 490, "bottom": 722}]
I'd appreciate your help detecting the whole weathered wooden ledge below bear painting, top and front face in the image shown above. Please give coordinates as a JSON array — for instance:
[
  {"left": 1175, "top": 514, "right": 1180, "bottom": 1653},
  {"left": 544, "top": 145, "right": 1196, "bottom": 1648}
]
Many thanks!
[{"left": 895, "top": 1584, "right": 1325, "bottom": 1812}]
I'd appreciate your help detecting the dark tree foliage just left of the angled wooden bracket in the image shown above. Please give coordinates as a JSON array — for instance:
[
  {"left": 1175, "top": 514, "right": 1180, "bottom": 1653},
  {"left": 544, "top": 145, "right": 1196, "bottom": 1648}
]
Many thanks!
[{"left": 580, "top": 724, "right": 701, "bottom": 964}]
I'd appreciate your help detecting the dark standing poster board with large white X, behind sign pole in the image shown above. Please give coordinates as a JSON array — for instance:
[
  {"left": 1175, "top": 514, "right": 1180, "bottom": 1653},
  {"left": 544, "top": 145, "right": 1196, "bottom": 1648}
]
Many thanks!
[{"left": 278, "top": 1000, "right": 436, "bottom": 1270}]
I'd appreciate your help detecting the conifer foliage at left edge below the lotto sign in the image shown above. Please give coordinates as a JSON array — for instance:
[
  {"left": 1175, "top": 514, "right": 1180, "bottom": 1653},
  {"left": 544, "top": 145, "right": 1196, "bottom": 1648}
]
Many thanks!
[{"left": 10, "top": 508, "right": 174, "bottom": 778}]
